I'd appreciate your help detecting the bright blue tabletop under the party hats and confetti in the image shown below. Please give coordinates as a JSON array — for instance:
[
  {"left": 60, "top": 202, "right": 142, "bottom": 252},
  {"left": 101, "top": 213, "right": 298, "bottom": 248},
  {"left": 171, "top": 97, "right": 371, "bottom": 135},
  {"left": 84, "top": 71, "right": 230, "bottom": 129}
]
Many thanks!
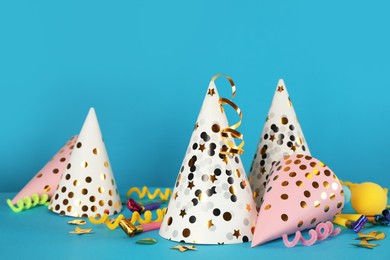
[{"left": 0, "top": 193, "right": 390, "bottom": 259}]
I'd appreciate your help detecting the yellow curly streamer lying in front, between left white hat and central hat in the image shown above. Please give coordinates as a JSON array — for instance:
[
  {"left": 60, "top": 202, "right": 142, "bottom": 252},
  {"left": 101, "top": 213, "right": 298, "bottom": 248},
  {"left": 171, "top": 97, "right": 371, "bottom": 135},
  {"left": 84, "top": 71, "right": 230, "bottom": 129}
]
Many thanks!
[{"left": 89, "top": 208, "right": 167, "bottom": 230}]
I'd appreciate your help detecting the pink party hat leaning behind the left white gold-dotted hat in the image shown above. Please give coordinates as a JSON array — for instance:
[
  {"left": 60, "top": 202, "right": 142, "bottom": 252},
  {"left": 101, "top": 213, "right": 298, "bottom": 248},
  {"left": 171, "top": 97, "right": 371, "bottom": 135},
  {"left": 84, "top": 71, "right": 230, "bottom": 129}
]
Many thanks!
[{"left": 12, "top": 136, "right": 77, "bottom": 204}]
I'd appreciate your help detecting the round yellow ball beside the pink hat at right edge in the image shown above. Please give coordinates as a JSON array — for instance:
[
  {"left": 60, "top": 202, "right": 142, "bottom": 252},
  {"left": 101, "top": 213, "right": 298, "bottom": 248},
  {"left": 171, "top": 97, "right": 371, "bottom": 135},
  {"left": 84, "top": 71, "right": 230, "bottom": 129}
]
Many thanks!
[{"left": 351, "top": 182, "right": 387, "bottom": 216}]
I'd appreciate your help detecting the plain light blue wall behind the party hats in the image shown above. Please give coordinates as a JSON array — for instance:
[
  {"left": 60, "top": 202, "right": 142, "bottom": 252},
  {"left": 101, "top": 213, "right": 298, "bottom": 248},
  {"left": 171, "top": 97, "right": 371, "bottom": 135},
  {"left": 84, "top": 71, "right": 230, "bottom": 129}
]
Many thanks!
[{"left": 0, "top": 0, "right": 390, "bottom": 193}]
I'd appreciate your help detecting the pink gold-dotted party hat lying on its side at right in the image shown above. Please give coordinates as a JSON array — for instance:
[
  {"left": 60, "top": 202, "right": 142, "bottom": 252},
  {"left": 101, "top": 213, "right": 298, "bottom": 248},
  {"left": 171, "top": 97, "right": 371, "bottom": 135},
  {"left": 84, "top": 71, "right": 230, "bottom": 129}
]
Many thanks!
[{"left": 252, "top": 154, "right": 344, "bottom": 247}]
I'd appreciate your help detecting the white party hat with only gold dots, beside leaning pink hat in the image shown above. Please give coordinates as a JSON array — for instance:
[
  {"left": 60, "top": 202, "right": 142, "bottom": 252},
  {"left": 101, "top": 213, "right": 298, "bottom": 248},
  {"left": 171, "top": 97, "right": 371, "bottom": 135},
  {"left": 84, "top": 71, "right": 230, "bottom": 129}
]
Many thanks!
[{"left": 49, "top": 108, "right": 122, "bottom": 217}]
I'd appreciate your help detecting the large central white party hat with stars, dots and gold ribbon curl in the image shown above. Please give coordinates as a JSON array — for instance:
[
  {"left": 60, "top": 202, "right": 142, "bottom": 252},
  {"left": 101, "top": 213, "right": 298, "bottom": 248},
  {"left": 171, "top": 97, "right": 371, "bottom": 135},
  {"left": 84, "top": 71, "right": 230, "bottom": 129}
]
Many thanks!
[{"left": 160, "top": 75, "right": 257, "bottom": 244}]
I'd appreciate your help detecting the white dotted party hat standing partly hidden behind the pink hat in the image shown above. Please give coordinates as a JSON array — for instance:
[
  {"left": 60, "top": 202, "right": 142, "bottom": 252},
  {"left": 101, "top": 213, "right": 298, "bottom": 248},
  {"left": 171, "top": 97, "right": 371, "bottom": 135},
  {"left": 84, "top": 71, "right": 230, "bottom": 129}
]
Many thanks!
[{"left": 249, "top": 79, "right": 310, "bottom": 207}]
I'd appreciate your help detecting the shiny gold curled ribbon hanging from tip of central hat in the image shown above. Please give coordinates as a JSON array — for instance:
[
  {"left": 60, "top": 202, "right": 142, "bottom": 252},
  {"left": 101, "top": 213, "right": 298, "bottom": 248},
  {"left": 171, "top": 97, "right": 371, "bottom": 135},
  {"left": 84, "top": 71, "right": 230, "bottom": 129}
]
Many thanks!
[{"left": 211, "top": 74, "right": 245, "bottom": 155}]
